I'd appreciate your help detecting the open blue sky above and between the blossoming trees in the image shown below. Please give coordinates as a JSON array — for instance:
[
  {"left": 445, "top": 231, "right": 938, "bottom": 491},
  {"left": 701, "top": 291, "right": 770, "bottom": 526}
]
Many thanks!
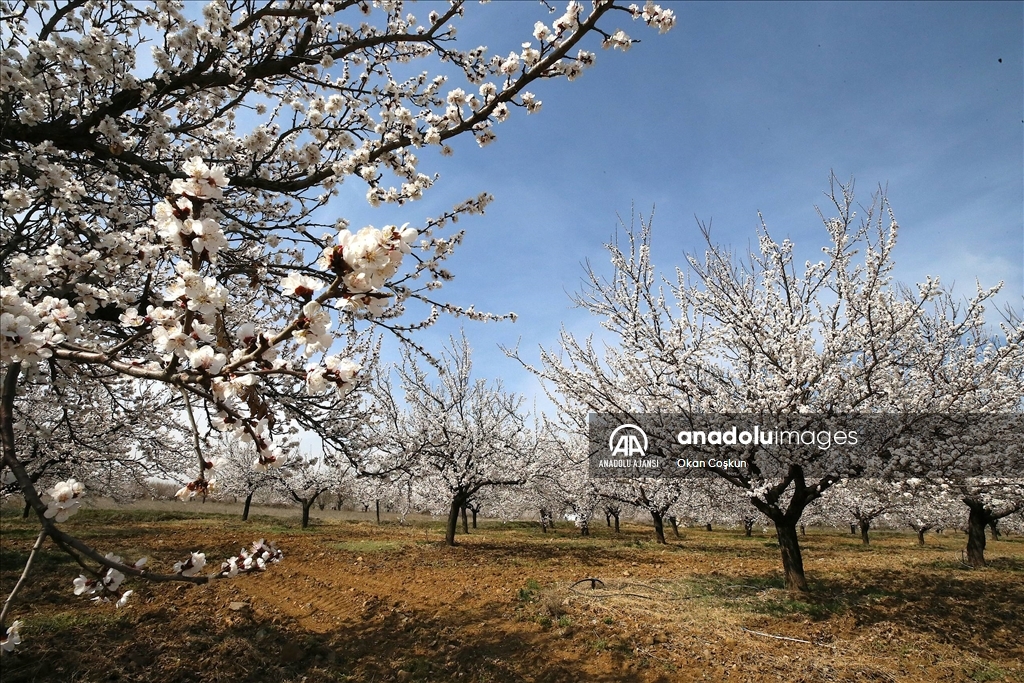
[{"left": 331, "top": 2, "right": 1024, "bottom": 407}]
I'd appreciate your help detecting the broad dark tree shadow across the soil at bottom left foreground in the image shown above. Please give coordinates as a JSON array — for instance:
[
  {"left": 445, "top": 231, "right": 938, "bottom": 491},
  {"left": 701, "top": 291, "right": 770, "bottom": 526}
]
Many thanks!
[{"left": 4, "top": 603, "right": 671, "bottom": 683}]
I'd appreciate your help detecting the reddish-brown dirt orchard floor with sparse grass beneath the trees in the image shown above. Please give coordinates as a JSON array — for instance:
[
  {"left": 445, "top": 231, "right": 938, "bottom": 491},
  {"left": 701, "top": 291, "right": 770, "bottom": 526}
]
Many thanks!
[{"left": 0, "top": 506, "right": 1024, "bottom": 683}]
